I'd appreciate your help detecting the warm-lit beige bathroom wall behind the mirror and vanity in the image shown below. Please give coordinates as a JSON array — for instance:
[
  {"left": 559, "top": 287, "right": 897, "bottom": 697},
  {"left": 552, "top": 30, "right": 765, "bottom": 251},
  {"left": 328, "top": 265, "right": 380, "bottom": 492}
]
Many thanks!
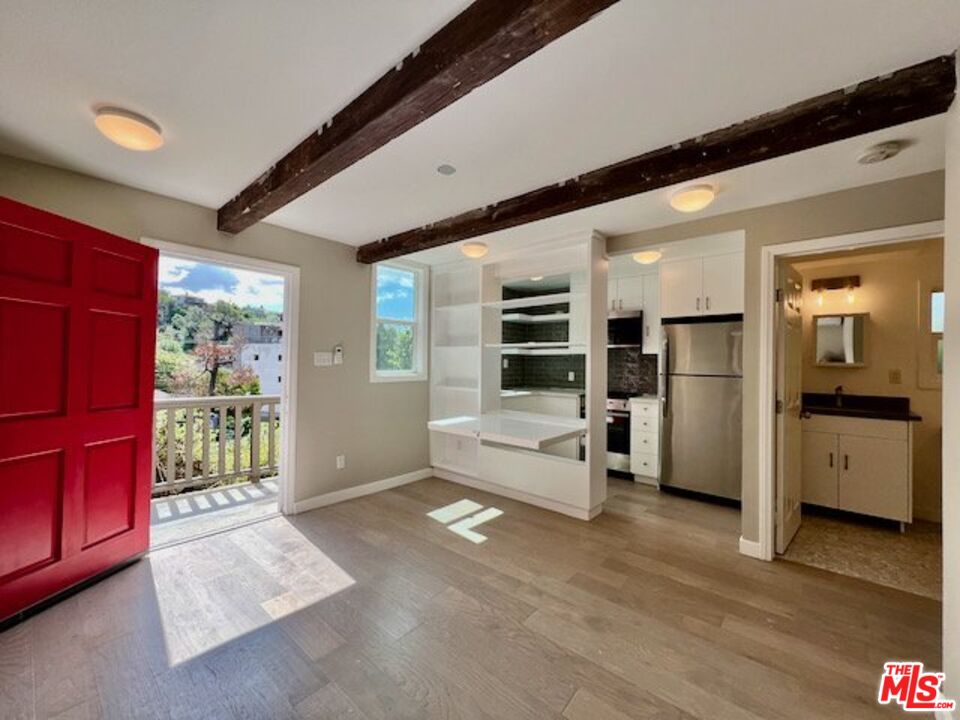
[{"left": 794, "top": 238, "right": 943, "bottom": 522}]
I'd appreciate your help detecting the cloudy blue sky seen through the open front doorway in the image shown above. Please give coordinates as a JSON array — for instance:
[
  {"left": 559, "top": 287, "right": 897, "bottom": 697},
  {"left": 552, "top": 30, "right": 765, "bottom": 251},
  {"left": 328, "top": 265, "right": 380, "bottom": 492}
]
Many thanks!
[{"left": 160, "top": 255, "right": 283, "bottom": 312}]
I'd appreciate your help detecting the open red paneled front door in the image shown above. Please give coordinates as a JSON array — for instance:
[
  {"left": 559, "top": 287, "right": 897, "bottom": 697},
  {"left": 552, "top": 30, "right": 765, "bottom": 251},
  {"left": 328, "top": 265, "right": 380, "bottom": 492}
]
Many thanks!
[{"left": 0, "top": 198, "right": 157, "bottom": 620}]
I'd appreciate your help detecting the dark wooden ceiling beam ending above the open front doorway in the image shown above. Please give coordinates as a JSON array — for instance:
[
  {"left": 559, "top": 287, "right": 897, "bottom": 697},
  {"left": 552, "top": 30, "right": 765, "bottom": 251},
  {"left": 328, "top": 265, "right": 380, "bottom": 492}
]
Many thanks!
[{"left": 217, "top": 0, "right": 617, "bottom": 233}]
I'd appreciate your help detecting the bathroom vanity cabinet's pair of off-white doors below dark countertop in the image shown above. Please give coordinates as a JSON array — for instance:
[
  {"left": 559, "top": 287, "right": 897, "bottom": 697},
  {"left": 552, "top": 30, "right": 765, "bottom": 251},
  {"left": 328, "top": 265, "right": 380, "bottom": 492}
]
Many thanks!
[{"left": 802, "top": 415, "right": 913, "bottom": 522}]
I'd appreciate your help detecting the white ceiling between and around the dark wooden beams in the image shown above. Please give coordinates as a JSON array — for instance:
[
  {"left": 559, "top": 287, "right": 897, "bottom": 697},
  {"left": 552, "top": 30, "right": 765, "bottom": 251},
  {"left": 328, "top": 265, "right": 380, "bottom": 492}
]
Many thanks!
[{"left": 0, "top": 0, "right": 960, "bottom": 245}]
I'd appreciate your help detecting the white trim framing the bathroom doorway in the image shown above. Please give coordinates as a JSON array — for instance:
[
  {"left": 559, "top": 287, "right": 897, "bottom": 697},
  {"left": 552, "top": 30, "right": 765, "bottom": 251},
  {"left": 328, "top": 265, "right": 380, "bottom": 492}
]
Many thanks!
[{"left": 752, "top": 220, "right": 944, "bottom": 560}]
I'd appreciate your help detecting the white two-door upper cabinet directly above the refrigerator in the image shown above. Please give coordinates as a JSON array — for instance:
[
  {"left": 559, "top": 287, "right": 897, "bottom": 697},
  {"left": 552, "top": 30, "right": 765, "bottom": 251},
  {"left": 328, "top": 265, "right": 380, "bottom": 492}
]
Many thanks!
[{"left": 660, "top": 252, "right": 743, "bottom": 318}]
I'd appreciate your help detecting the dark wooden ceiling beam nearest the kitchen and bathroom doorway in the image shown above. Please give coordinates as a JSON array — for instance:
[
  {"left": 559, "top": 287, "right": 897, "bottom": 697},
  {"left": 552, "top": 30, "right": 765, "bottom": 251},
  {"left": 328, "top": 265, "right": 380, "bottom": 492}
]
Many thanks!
[{"left": 357, "top": 55, "right": 957, "bottom": 263}]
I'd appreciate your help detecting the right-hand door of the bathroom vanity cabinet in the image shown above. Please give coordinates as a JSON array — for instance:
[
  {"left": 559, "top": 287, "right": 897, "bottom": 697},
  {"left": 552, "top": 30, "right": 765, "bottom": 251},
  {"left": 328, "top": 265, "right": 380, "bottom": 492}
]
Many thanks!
[{"left": 839, "top": 435, "right": 912, "bottom": 522}]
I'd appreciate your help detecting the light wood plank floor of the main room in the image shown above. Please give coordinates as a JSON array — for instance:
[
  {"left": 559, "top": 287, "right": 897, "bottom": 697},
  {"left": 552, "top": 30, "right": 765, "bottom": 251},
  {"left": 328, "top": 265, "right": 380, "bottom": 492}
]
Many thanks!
[{"left": 0, "top": 480, "right": 940, "bottom": 720}]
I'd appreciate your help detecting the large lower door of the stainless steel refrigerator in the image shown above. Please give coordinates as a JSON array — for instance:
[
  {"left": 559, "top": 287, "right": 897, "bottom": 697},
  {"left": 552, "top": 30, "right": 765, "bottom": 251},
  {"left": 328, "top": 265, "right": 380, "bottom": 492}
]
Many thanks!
[{"left": 660, "top": 375, "right": 743, "bottom": 500}]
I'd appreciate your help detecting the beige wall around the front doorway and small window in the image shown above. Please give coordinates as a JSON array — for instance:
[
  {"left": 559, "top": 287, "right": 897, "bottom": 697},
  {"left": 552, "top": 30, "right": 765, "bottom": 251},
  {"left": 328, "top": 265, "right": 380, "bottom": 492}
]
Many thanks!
[{"left": 0, "top": 155, "right": 430, "bottom": 500}]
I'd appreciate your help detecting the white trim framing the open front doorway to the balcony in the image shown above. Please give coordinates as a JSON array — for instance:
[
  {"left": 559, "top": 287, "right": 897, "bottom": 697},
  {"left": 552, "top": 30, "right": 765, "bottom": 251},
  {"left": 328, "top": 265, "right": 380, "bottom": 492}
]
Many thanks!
[{"left": 140, "top": 237, "right": 300, "bottom": 515}]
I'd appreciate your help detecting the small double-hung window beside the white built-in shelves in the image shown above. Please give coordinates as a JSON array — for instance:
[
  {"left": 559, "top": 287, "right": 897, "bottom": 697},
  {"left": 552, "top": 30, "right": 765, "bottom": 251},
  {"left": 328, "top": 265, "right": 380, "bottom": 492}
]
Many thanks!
[{"left": 370, "top": 263, "right": 427, "bottom": 382}]
